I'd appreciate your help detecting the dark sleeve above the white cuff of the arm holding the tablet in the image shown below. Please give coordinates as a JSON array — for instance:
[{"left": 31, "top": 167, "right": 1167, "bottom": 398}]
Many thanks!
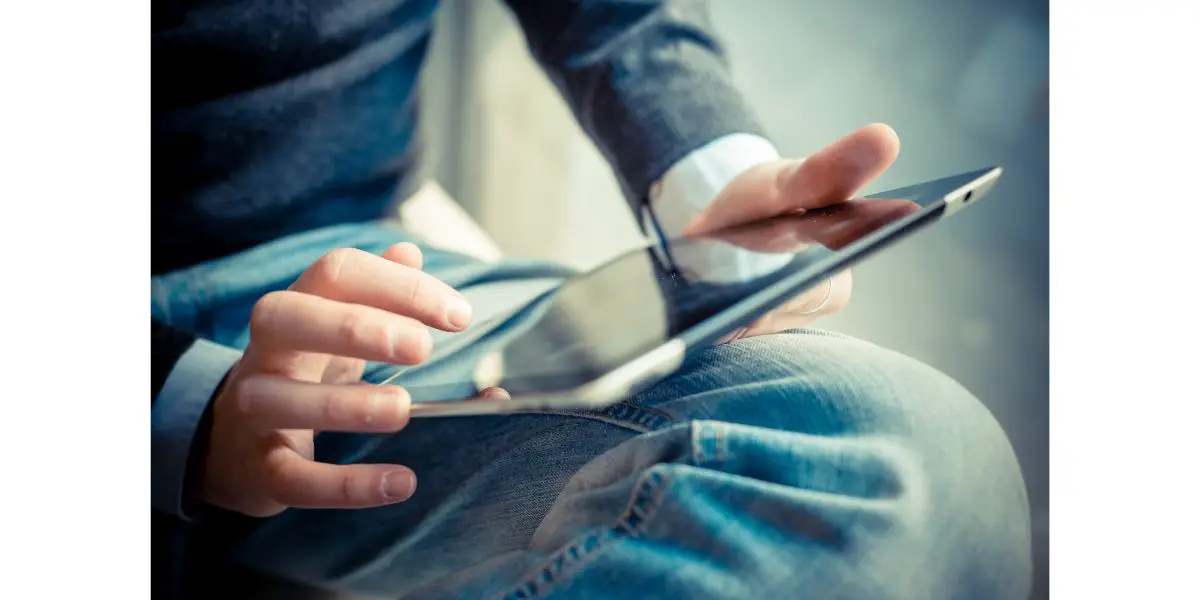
[{"left": 499, "top": 0, "right": 764, "bottom": 206}]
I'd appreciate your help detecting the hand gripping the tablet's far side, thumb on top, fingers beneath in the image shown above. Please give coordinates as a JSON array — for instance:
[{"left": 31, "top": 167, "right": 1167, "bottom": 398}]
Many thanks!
[{"left": 683, "top": 124, "right": 900, "bottom": 338}]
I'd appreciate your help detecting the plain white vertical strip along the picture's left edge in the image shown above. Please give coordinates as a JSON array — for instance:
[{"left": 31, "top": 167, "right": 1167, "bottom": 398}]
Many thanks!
[{"left": 0, "top": 1, "right": 150, "bottom": 599}]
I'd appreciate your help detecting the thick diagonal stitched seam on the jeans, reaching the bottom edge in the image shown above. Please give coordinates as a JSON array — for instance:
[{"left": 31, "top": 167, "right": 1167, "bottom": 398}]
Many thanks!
[{"left": 494, "top": 467, "right": 670, "bottom": 600}]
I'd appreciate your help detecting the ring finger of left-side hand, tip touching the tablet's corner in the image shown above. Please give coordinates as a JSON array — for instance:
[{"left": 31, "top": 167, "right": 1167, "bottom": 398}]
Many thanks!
[{"left": 235, "top": 374, "right": 410, "bottom": 433}]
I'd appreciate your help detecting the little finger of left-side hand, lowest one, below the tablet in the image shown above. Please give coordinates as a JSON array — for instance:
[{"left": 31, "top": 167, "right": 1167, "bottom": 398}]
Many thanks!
[{"left": 266, "top": 448, "right": 416, "bottom": 509}]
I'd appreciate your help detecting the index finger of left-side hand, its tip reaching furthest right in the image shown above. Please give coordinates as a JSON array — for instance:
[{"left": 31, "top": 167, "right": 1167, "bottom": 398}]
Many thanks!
[{"left": 293, "top": 248, "right": 470, "bottom": 331}]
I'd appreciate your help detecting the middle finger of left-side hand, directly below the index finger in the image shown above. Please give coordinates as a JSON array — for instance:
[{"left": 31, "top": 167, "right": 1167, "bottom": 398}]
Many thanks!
[{"left": 250, "top": 292, "right": 433, "bottom": 365}]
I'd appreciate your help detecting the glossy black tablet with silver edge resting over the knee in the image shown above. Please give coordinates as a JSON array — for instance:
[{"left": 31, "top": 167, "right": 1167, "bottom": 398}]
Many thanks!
[{"left": 412, "top": 167, "right": 1001, "bottom": 418}]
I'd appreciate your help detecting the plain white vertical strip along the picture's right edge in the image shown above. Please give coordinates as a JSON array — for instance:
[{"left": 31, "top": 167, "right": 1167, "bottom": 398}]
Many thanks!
[{"left": 1050, "top": 0, "right": 1200, "bottom": 599}]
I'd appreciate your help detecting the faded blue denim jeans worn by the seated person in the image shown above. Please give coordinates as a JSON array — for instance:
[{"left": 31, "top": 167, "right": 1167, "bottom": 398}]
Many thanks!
[{"left": 152, "top": 224, "right": 1031, "bottom": 600}]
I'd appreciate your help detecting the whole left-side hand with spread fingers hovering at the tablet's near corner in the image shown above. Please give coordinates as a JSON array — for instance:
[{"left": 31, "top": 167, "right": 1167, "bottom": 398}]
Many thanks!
[{"left": 197, "top": 244, "right": 470, "bottom": 517}]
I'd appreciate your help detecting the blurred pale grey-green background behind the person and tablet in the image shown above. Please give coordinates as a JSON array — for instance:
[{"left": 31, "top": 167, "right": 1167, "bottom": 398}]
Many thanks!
[{"left": 422, "top": 0, "right": 1049, "bottom": 599}]
